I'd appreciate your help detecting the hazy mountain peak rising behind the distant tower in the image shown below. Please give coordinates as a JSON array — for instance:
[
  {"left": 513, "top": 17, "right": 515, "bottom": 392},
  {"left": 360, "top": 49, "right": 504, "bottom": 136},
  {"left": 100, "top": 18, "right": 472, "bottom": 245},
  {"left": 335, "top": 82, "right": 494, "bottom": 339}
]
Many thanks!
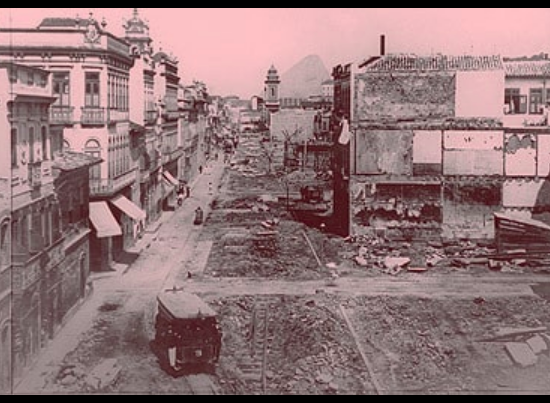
[{"left": 280, "top": 55, "right": 331, "bottom": 99}]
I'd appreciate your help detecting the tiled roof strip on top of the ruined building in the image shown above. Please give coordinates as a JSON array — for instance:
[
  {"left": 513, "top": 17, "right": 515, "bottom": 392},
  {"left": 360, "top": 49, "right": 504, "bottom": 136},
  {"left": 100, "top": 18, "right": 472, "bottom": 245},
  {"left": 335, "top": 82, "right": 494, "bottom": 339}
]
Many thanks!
[{"left": 365, "top": 54, "right": 504, "bottom": 72}]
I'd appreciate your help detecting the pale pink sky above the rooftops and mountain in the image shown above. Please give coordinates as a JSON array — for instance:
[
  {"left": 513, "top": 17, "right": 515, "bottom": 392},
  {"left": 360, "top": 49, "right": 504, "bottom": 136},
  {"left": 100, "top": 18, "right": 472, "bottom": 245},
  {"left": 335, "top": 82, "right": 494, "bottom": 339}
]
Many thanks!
[{"left": 0, "top": 8, "right": 550, "bottom": 97}]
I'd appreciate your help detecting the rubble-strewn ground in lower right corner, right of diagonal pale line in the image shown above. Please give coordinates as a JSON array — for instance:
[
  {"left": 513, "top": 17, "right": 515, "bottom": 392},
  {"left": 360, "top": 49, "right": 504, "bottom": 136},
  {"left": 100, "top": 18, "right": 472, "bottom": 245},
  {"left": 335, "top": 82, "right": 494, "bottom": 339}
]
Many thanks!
[{"left": 348, "top": 297, "right": 550, "bottom": 393}]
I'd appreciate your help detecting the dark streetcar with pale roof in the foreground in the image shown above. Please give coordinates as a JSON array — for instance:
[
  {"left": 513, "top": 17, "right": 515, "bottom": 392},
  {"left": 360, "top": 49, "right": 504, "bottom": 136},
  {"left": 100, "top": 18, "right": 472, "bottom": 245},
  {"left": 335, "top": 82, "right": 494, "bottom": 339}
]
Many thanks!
[{"left": 153, "top": 289, "right": 222, "bottom": 377}]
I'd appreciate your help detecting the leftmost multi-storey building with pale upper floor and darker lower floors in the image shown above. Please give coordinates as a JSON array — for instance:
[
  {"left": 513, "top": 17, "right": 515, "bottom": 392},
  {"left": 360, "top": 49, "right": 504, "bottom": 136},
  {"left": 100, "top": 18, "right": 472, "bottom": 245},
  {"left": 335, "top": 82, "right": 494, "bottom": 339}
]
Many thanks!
[{"left": 1, "top": 64, "right": 59, "bottom": 386}]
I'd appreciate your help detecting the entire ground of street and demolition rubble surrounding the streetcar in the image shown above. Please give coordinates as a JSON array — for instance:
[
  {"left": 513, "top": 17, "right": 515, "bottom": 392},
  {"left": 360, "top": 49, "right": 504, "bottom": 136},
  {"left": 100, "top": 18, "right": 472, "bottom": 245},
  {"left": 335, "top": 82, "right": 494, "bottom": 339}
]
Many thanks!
[{"left": 19, "top": 139, "right": 550, "bottom": 394}]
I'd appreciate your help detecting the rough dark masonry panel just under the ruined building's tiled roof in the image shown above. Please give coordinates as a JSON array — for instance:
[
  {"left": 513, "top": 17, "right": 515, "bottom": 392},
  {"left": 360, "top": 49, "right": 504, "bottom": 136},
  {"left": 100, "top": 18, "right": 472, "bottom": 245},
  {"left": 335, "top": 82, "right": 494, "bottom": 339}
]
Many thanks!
[{"left": 354, "top": 72, "right": 456, "bottom": 121}]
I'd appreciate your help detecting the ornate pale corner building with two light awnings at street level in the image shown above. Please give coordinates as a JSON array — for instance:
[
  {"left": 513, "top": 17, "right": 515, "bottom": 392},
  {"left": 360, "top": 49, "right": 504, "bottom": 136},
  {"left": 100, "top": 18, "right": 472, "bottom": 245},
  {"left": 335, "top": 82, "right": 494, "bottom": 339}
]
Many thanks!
[{"left": 0, "top": 16, "right": 146, "bottom": 270}]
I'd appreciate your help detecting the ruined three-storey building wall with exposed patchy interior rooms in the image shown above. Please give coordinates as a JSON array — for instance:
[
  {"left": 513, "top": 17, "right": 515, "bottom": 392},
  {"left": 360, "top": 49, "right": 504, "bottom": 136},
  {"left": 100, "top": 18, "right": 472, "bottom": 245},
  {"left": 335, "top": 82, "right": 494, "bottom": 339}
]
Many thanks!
[{"left": 349, "top": 55, "right": 516, "bottom": 240}]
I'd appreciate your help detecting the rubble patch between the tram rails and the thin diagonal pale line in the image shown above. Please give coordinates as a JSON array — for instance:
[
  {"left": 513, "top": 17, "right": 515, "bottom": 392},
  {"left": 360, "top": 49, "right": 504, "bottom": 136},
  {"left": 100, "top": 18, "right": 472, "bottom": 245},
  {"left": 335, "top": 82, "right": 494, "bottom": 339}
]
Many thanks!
[{"left": 269, "top": 295, "right": 369, "bottom": 394}]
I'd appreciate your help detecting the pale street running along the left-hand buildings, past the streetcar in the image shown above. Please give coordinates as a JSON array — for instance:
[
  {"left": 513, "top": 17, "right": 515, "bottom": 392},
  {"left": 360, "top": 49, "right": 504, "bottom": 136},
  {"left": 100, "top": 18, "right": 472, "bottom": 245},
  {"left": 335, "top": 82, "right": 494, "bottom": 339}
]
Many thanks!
[{"left": 16, "top": 165, "right": 224, "bottom": 394}]
